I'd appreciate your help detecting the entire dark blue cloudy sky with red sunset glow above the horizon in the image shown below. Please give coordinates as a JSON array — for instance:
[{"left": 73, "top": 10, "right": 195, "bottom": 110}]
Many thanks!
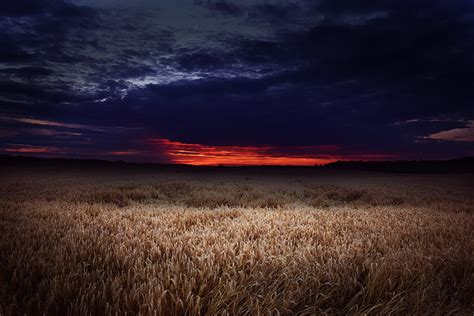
[{"left": 0, "top": 0, "right": 474, "bottom": 165}]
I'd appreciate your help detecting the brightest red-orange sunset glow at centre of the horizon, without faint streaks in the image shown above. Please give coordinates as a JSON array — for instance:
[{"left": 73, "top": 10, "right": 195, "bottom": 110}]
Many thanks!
[{"left": 151, "top": 138, "right": 338, "bottom": 166}]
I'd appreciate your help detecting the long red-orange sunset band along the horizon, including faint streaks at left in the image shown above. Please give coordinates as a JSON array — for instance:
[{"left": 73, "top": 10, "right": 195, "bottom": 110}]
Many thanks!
[{"left": 0, "top": 138, "right": 394, "bottom": 166}]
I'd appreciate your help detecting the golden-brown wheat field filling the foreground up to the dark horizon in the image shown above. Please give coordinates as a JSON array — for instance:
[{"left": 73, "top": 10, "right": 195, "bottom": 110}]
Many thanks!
[{"left": 0, "top": 168, "right": 474, "bottom": 315}]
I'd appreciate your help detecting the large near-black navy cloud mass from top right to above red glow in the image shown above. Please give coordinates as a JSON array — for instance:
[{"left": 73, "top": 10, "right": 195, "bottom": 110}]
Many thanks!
[{"left": 126, "top": 1, "right": 474, "bottom": 156}]
